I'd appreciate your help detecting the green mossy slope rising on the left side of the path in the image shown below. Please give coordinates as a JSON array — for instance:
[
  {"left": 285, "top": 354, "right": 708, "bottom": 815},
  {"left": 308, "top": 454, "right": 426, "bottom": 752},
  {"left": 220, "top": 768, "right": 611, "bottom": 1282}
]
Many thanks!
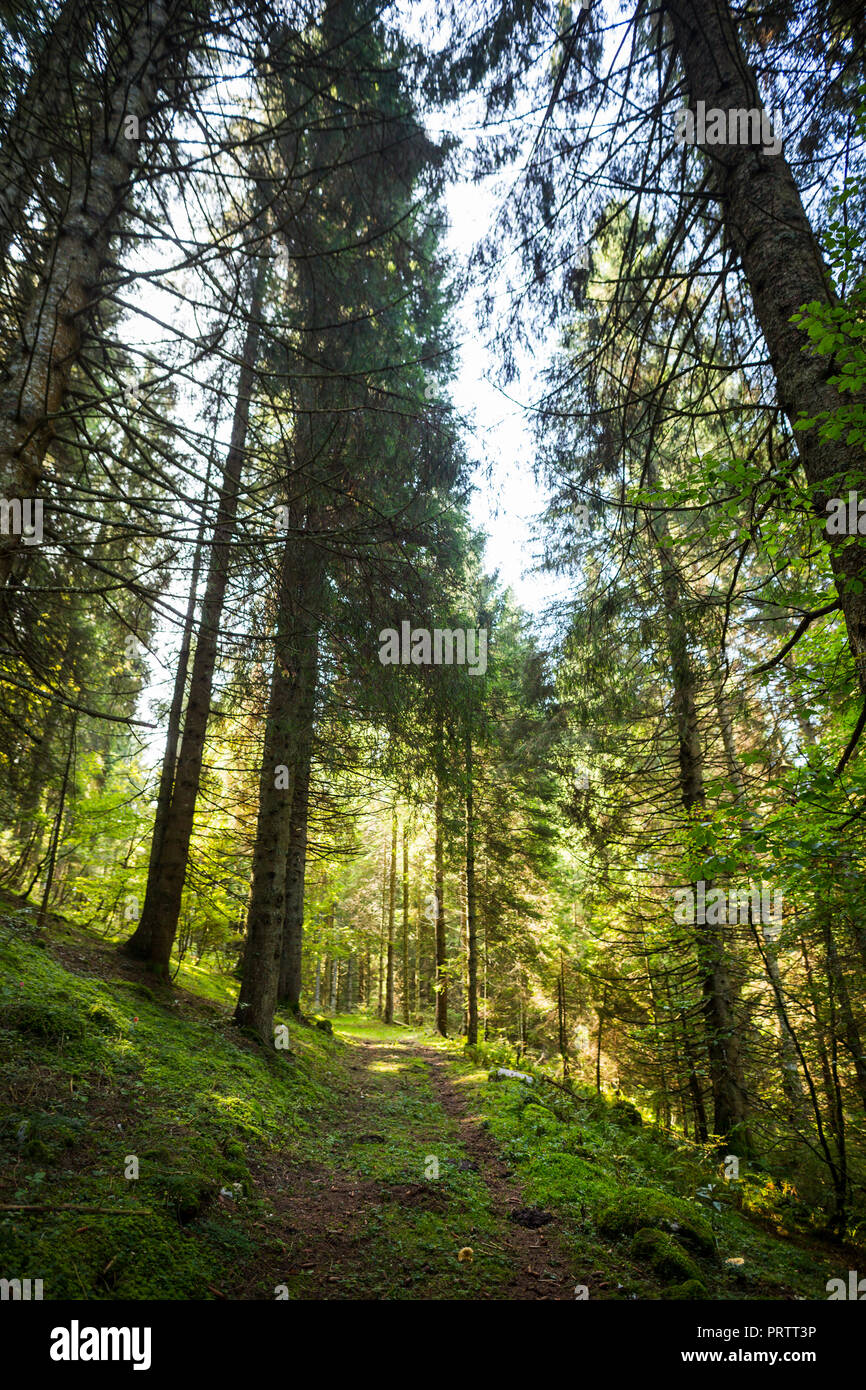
[{"left": 0, "top": 929, "right": 348, "bottom": 1300}]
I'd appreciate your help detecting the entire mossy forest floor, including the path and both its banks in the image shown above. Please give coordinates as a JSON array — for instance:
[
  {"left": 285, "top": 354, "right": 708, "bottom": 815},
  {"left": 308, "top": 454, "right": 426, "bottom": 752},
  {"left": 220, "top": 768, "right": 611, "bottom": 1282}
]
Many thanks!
[{"left": 0, "top": 905, "right": 855, "bottom": 1300}]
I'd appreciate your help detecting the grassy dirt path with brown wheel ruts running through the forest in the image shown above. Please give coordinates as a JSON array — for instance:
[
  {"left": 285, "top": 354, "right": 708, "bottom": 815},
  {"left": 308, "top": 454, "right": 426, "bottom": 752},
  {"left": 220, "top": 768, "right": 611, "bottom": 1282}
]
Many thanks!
[{"left": 237, "top": 1030, "right": 575, "bottom": 1300}]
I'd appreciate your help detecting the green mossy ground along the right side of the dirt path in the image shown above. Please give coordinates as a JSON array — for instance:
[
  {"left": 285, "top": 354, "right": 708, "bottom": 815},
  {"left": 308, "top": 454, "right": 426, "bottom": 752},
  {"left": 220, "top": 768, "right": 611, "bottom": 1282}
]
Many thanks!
[{"left": 453, "top": 1048, "right": 865, "bottom": 1300}]
